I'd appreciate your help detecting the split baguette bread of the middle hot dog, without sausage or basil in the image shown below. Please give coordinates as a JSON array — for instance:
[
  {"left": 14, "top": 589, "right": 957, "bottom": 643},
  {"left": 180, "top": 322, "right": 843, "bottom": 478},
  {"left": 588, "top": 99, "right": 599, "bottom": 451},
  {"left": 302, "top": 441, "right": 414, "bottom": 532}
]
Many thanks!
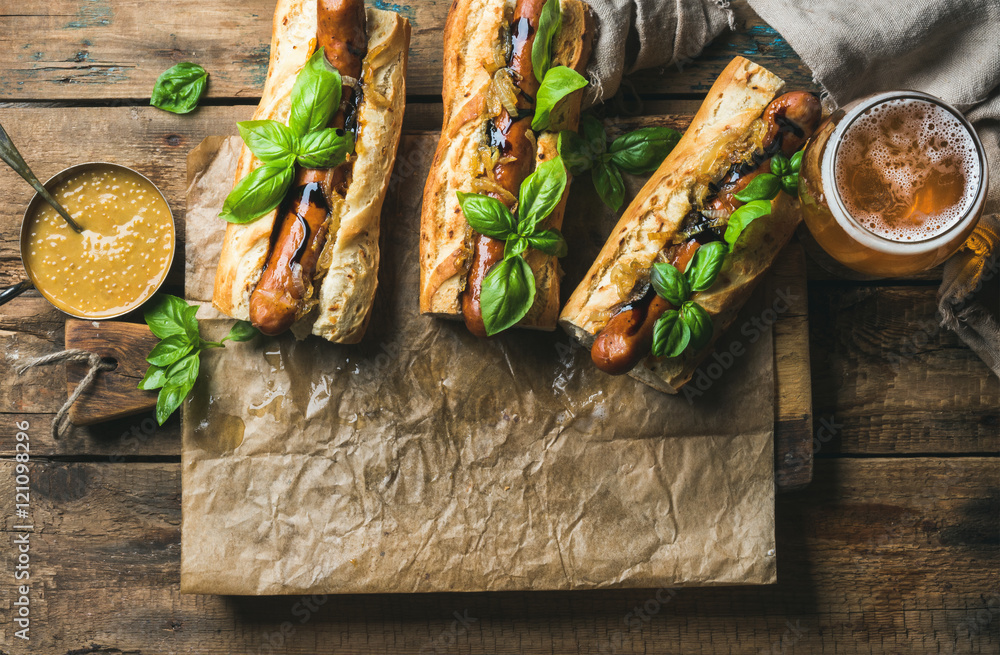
[{"left": 420, "top": 0, "right": 594, "bottom": 330}]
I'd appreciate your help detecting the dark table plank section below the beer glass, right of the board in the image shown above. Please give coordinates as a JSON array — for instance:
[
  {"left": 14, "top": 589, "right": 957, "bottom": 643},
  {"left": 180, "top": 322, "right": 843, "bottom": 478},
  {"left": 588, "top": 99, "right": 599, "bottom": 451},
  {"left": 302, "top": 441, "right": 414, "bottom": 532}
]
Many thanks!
[{"left": 809, "top": 284, "right": 1000, "bottom": 454}]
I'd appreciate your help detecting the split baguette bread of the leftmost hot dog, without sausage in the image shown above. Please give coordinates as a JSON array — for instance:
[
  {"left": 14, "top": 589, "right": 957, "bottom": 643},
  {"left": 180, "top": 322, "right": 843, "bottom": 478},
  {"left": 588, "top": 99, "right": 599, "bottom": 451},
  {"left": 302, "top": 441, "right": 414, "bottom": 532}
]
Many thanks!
[{"left": 212, "top": 0, "right": 410, "bottom": 343}]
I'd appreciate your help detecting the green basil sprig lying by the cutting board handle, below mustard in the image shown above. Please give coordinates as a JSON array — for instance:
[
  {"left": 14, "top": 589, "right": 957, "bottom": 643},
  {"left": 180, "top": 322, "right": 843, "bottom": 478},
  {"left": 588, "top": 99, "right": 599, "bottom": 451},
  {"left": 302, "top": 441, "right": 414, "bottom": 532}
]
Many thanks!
[{"left": 139, "top": 295, "right": 257, "bottom": 425}]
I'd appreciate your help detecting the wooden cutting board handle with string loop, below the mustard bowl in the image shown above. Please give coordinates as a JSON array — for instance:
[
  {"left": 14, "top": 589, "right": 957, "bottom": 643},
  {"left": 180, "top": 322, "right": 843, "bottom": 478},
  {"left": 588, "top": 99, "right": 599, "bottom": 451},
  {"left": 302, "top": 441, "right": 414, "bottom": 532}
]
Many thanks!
[{"left": 65, "top": 319, "right": 160, "bottom": 425}]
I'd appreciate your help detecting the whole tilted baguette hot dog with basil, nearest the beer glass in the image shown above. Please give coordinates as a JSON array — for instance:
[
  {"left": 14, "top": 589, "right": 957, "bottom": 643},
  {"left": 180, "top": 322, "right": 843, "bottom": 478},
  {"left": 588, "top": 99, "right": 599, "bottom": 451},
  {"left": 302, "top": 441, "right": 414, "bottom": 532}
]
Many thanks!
[{"left": 560, "top": 57, "right": 822, "bottom": 393}]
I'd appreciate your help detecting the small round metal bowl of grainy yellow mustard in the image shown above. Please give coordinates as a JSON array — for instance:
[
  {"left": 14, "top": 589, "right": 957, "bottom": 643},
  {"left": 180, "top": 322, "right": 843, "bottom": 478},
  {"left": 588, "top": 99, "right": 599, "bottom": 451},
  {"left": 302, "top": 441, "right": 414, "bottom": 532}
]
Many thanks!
[{"left": 21, "top": 162, "right": 177, "bottom": 320}]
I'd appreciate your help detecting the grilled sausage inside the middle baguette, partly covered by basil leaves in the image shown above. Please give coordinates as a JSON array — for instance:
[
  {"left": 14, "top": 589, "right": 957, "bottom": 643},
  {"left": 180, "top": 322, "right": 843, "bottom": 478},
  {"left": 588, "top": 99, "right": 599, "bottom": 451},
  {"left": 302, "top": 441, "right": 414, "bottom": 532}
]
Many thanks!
[{"left": 462, "top": 0, "right": 545, "bottom": 337}]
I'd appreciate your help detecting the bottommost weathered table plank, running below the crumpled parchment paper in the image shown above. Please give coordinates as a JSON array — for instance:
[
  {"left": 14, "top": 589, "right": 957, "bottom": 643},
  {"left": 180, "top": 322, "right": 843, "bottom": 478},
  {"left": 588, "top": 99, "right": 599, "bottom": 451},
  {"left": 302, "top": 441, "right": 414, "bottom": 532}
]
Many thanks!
[{"left": 0, "top": 458, "right": 1000, "bottom": 655}]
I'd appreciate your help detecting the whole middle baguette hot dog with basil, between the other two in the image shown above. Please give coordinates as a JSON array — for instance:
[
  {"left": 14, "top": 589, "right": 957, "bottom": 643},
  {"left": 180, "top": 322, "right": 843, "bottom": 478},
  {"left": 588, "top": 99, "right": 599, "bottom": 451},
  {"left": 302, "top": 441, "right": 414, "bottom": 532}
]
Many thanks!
[{"left": 420, "top": 0, "right": 593, "bottom": 336}]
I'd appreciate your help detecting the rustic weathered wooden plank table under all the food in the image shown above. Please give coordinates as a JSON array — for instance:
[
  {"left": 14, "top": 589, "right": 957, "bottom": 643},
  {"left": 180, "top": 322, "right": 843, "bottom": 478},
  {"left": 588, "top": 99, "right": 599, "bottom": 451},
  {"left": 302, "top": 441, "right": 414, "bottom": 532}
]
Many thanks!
[{"left": 0, "top": 0, "right": 1000, "bottom": 654}]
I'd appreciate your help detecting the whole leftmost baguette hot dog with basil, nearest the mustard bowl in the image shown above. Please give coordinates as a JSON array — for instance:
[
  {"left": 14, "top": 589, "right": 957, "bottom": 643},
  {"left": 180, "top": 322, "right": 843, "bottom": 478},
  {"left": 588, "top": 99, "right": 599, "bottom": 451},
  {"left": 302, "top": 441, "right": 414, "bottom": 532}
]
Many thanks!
[{"left": 213, "top": 0, "right": 410, "bottom": 343}]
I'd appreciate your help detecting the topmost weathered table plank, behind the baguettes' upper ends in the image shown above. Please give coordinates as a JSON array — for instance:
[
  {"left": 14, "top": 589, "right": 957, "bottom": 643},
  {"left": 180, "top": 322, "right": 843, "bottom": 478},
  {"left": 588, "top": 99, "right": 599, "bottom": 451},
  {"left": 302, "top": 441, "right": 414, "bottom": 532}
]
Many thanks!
[{"left": 0, "top": 0, "right": 813, "bottom": 101}]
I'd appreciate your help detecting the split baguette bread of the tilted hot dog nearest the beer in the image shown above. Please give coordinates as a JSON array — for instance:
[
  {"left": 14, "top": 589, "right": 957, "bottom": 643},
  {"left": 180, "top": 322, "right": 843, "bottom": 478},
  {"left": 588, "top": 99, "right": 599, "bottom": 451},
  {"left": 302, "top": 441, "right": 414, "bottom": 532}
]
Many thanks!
[{"left": 559, "top": 57, "right": 799, "bottom": 393}]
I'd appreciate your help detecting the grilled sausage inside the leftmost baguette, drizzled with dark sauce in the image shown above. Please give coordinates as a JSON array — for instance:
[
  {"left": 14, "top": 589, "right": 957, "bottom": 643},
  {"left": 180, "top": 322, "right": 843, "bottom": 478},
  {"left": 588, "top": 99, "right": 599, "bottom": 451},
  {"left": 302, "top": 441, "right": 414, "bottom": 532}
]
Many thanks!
[{"left": 250, "top": 0, "right": 368, "bottom": 335}]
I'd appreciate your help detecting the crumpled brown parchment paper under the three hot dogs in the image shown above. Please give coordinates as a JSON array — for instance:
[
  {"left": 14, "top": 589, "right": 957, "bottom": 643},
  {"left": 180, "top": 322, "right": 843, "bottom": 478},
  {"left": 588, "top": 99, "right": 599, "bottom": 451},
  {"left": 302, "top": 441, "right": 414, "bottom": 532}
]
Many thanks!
[{"left": 181, "top": 134, "right": 776, "bottom": 594}]
